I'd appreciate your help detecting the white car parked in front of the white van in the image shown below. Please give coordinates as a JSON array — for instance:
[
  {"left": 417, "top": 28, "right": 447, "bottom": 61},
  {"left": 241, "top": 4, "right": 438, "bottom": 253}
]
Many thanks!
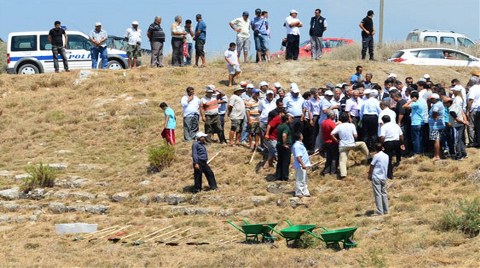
[{"left": 388, "top": 48, "right": 480, "bottom": 67}]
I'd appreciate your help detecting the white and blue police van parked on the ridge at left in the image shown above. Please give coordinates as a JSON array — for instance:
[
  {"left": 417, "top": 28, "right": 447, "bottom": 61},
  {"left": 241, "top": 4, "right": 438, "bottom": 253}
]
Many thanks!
[{"left": 7, "top": 31, "right": 128, "bottom": 74}]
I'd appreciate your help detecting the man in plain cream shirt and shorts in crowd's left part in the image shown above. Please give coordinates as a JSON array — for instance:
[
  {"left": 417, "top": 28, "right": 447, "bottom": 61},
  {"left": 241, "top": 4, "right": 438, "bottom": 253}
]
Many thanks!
[{"left": 227, "top": 87, "right": 245, "bottom": 146}]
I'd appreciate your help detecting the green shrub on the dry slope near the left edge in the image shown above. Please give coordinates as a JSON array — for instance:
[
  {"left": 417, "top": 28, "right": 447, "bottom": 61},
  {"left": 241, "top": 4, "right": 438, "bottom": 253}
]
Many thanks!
[{"left": 22, "top": 163, "right": 57, "bottom": 192}]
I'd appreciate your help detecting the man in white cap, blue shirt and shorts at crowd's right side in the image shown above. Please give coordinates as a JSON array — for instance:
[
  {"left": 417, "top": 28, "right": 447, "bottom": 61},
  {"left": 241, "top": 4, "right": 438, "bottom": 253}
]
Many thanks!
[{"left": 428, "top": 93, "right": 445, "bottom": 160}]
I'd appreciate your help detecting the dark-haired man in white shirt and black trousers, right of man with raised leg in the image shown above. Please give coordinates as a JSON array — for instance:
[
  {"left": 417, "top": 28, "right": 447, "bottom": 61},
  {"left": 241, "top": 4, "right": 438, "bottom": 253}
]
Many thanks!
[{"left": 380, "top": 115, "right": 405, "bottom": 179}]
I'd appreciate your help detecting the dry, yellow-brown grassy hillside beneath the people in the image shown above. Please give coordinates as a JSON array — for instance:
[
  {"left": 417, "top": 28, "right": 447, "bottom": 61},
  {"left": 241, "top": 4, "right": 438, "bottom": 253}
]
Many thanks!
[{"left": 0, "top": 60, "right": 480, "bottom": 267}]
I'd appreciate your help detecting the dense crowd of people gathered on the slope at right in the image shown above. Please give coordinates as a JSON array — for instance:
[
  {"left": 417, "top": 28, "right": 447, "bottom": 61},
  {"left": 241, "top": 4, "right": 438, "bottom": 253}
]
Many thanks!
[{"left": 161, "top": 66, "right": 480, "bottom": 214}]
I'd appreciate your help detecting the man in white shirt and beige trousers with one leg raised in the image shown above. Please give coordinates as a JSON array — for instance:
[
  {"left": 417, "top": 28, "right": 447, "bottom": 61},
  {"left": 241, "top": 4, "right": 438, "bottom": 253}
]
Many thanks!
[{"left": 332, "top": 113, "right": 369, "bottom": 179}]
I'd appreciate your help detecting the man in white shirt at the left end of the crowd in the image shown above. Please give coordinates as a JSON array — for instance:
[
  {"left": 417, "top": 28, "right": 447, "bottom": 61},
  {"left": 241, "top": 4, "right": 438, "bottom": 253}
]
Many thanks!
[{"left": 180, "top": 87, "right": 200, "bottom": 141}]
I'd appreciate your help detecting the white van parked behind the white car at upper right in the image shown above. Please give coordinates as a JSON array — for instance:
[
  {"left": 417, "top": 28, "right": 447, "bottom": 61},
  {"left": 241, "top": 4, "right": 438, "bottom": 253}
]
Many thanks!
[{"left": 407, "top": 29, "right": 475, "bottom": 47}]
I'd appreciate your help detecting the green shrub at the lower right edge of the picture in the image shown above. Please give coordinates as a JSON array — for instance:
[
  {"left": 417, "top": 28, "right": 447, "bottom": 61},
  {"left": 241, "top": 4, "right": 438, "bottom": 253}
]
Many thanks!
[{"left": 437, "top": 197, "right": 480, "bottom": 237}]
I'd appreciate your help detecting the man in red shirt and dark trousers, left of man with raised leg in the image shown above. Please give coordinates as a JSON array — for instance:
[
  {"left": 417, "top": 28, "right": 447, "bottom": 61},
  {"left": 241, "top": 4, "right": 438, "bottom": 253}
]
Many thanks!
[{"left": 320, "top": 111, "right": 338, "bottom": 176}]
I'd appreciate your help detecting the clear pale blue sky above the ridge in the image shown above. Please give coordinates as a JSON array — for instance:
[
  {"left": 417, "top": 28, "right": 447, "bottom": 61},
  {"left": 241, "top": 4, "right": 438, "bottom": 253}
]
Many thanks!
[{"left": 0, "top": 0, "right": 480, "bottom": 54}]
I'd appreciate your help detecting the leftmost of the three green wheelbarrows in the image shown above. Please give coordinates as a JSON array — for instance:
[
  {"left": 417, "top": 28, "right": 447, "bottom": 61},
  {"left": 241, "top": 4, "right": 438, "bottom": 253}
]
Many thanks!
[{"left": 227, "top": 219, "right": 277, "bottom": 243}]
